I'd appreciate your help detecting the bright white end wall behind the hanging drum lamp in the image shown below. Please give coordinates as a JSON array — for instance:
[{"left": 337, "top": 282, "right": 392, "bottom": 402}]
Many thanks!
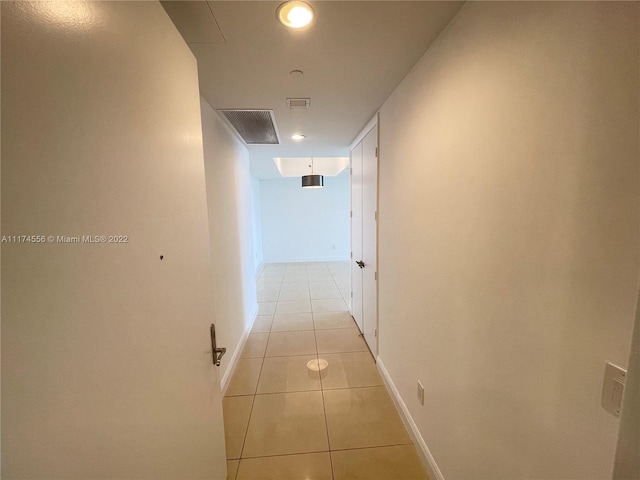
[{"left": 260, "top": 177, "right": 349, "bottom": 263}]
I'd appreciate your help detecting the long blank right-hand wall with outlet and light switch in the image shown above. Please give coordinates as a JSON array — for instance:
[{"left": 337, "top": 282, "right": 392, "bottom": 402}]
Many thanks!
[{"left": 379, "top": 2, "right": 640, "bottom": 480}]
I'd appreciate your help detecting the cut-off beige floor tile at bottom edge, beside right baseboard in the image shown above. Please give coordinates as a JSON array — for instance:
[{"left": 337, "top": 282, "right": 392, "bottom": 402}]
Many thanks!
[{"left": 331, "top": 445, "right": 429, "bottom": 480}]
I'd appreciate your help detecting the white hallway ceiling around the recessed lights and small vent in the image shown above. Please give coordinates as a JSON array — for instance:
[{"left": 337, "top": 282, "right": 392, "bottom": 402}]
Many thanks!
[{"left": 162, "top": 1, "right": 462, "bottom": 179}]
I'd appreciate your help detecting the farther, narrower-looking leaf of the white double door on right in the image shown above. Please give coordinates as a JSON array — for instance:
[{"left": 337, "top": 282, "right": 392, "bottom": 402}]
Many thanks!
[{"left": 351, "top": 142, "right": 364, "bottom": 332}]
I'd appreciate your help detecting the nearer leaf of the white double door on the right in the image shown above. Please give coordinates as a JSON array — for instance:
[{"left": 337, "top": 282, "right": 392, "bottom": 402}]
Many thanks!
[{"left": 362, "top": 125, "right": 378, "bottom": 357}]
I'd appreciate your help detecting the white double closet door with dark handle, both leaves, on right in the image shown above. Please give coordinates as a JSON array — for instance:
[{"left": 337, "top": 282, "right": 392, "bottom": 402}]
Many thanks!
[{"left": 351, "top": 119, "right": 378, "bottom": 357}]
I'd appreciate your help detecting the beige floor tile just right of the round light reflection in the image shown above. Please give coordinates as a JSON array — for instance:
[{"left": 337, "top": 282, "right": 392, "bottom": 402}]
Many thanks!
[{"left": 320, "top": 352, "right": 384, "bottom": 389}]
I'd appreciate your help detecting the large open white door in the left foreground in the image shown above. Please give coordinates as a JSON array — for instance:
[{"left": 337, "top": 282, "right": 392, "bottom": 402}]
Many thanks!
[{"left": 1, "top": 1, "right": 226, "bottom": 480}]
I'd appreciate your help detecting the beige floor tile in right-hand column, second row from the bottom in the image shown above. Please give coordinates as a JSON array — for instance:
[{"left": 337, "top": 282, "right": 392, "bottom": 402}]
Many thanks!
[{"left": 323, "top": 387, "right": 411, "bottom": 450}]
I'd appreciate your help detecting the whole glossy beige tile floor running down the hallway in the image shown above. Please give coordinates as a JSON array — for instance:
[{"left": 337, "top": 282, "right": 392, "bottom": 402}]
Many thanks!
[{"left": 223, "top": 262, "right": 428, "bottom": 480}]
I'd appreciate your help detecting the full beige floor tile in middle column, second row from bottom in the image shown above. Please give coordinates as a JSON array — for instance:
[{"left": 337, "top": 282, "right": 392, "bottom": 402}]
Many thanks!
[{"left": 241, "top": 390, "right": 328, "bottom": 458}]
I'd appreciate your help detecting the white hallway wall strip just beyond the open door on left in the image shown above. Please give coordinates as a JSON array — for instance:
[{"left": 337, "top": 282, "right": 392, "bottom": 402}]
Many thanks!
[{"left": 200, "top": 99, "right": 258, "bottom": 378}]
